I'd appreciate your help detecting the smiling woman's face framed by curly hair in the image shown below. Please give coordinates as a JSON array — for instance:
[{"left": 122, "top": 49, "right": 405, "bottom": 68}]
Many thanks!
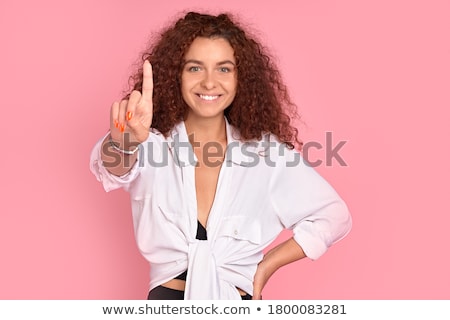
[{"left": 181, "top": 37, "right": 237, "bottom": 122}]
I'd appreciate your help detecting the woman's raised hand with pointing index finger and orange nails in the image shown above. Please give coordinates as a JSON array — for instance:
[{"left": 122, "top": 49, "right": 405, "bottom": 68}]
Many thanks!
[{"left": 110, "top": 60, "right": 153, "bottom": 148}]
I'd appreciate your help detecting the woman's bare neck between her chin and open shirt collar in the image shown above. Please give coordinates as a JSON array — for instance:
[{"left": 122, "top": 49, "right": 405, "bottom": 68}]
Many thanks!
[{"left": 184, "top": 115, "right": 227, "bottom": 143}]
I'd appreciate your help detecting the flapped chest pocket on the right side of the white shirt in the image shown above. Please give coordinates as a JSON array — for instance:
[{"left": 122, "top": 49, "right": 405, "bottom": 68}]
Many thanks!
[{"left": 218, "top": 216, "right": 261, "bottom": 245}]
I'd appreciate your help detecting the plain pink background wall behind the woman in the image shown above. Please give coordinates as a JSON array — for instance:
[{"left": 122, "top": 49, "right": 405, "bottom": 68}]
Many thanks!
[{"left": 0, "top": 0, "right": 450, "bottom": 299}]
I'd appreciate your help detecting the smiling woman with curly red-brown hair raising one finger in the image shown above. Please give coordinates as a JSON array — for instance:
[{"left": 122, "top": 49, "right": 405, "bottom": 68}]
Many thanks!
[{"left": 91, "top": 12, "right": 351, "bottom": 299}]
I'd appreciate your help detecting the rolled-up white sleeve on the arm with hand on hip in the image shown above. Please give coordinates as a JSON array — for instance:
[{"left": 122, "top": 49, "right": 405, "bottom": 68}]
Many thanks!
[{"left": 270, "top": 150, "right": 352, "bottom": 260}]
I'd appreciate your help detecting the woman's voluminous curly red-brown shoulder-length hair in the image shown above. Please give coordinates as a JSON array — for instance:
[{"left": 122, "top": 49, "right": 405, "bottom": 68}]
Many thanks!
[{"left": 128, "top": 12, "right": 302, "bottom": 148}]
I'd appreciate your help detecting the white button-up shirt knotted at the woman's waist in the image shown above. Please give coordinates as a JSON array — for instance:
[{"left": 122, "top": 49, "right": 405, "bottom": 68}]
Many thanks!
[{"left": 90, "top": 122, "right": 351, "bottom": 299}]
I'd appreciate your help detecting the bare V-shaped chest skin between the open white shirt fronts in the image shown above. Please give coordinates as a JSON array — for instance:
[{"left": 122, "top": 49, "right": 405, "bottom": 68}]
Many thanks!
[{"left": 194, "top": 143, "right": 226, "bottom": 227}]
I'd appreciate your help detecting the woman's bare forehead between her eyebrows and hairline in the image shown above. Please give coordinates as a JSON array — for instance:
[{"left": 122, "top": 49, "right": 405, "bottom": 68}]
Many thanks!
[{"left": 184, "top": 37, "right": 235, "bottom": 62}]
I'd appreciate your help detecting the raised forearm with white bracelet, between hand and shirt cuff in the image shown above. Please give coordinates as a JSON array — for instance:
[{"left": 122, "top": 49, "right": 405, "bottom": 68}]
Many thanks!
[{"left": 101, "top": 135, "right": 139, "bottom": 176}]
